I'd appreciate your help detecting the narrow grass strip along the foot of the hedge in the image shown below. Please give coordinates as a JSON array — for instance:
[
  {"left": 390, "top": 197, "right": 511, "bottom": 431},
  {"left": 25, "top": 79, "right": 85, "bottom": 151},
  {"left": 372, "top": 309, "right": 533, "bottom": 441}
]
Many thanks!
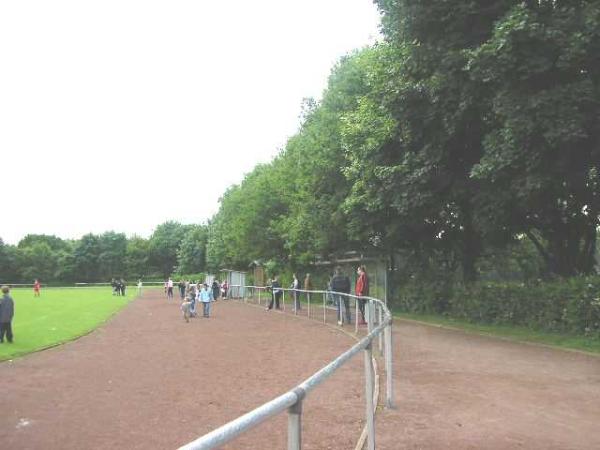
[{"left": 394, "top": 312, "right": 600, "bottom": 354}]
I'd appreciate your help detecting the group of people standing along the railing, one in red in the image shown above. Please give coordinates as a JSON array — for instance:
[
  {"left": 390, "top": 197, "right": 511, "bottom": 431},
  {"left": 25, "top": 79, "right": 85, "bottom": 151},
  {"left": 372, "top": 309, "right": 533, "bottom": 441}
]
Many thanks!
[{"left": 266, "top": 265, "right": 369, "bottom": 326}]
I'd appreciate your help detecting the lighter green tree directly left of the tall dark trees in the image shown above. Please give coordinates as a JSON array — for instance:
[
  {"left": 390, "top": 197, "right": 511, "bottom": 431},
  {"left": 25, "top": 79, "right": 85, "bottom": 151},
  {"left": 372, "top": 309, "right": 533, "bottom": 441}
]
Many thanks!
[{"left": 277, "top": 49, "right": 373, "bottom": 264}]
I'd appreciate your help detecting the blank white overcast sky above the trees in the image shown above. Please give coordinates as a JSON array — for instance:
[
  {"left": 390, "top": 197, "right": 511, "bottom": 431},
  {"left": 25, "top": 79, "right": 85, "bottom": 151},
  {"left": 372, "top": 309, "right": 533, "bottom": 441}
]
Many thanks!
[{"left": 0, "top": 0, "right": 379, "bottom": 244}]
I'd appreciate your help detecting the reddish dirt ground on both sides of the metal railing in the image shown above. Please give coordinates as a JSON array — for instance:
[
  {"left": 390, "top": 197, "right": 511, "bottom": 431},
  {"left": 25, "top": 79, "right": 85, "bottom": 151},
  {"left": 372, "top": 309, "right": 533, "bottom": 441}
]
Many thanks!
[{"left": 0, "top": 291, "right": 600, "bottom": 449}]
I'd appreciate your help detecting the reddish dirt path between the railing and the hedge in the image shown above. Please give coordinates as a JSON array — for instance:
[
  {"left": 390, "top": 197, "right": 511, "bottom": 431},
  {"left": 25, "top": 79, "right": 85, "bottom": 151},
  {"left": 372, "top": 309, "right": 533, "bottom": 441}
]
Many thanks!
[{"left": 376, "top": 321, "right": 600, "bottom": 450}]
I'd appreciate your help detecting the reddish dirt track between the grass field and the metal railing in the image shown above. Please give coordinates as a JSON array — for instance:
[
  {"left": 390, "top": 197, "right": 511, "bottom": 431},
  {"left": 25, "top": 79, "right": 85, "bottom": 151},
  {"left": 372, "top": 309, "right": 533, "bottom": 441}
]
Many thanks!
[{"left": 0, "top": 292, "right": 364, "bottom": 449}]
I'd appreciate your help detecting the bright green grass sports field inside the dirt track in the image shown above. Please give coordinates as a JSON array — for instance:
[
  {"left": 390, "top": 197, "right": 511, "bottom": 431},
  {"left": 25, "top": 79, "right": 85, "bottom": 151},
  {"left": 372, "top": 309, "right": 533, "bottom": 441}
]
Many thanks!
[{"left": 0, "top": 287, "right": 136, "bottom": 361}]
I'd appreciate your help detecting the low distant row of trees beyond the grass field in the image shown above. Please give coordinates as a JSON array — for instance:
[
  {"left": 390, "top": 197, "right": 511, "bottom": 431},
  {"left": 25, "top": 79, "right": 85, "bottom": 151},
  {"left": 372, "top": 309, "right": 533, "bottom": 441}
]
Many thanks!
[{"left": 0, "top": 221, "right": 208, "bottom": 283}]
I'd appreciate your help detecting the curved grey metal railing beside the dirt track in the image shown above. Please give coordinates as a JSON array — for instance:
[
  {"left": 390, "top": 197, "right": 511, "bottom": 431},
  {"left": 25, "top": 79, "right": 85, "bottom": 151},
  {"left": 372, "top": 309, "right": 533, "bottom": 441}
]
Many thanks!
[{"left": 180, "top": 286, "right": 394, "bottom": 450}]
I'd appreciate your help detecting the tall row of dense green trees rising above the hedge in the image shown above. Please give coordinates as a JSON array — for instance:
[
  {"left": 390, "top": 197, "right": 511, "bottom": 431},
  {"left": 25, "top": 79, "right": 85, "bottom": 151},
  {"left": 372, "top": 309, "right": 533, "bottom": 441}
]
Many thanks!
[{"left": 206, "top": 0, "right": 600, "bottom": 283}]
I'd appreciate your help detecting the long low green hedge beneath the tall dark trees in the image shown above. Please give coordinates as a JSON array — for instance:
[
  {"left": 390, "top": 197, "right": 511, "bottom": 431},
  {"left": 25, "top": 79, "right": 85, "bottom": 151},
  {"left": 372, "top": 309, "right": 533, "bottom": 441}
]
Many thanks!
[{"left": 396, "top": 276, "right": 600, "bottom": 339}]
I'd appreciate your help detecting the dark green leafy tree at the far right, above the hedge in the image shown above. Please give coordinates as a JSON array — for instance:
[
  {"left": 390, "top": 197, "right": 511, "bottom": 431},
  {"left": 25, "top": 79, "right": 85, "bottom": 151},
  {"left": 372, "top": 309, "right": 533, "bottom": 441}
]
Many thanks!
[{"left": 469, "top": 1, "right": 600, "bottom": 276}]
